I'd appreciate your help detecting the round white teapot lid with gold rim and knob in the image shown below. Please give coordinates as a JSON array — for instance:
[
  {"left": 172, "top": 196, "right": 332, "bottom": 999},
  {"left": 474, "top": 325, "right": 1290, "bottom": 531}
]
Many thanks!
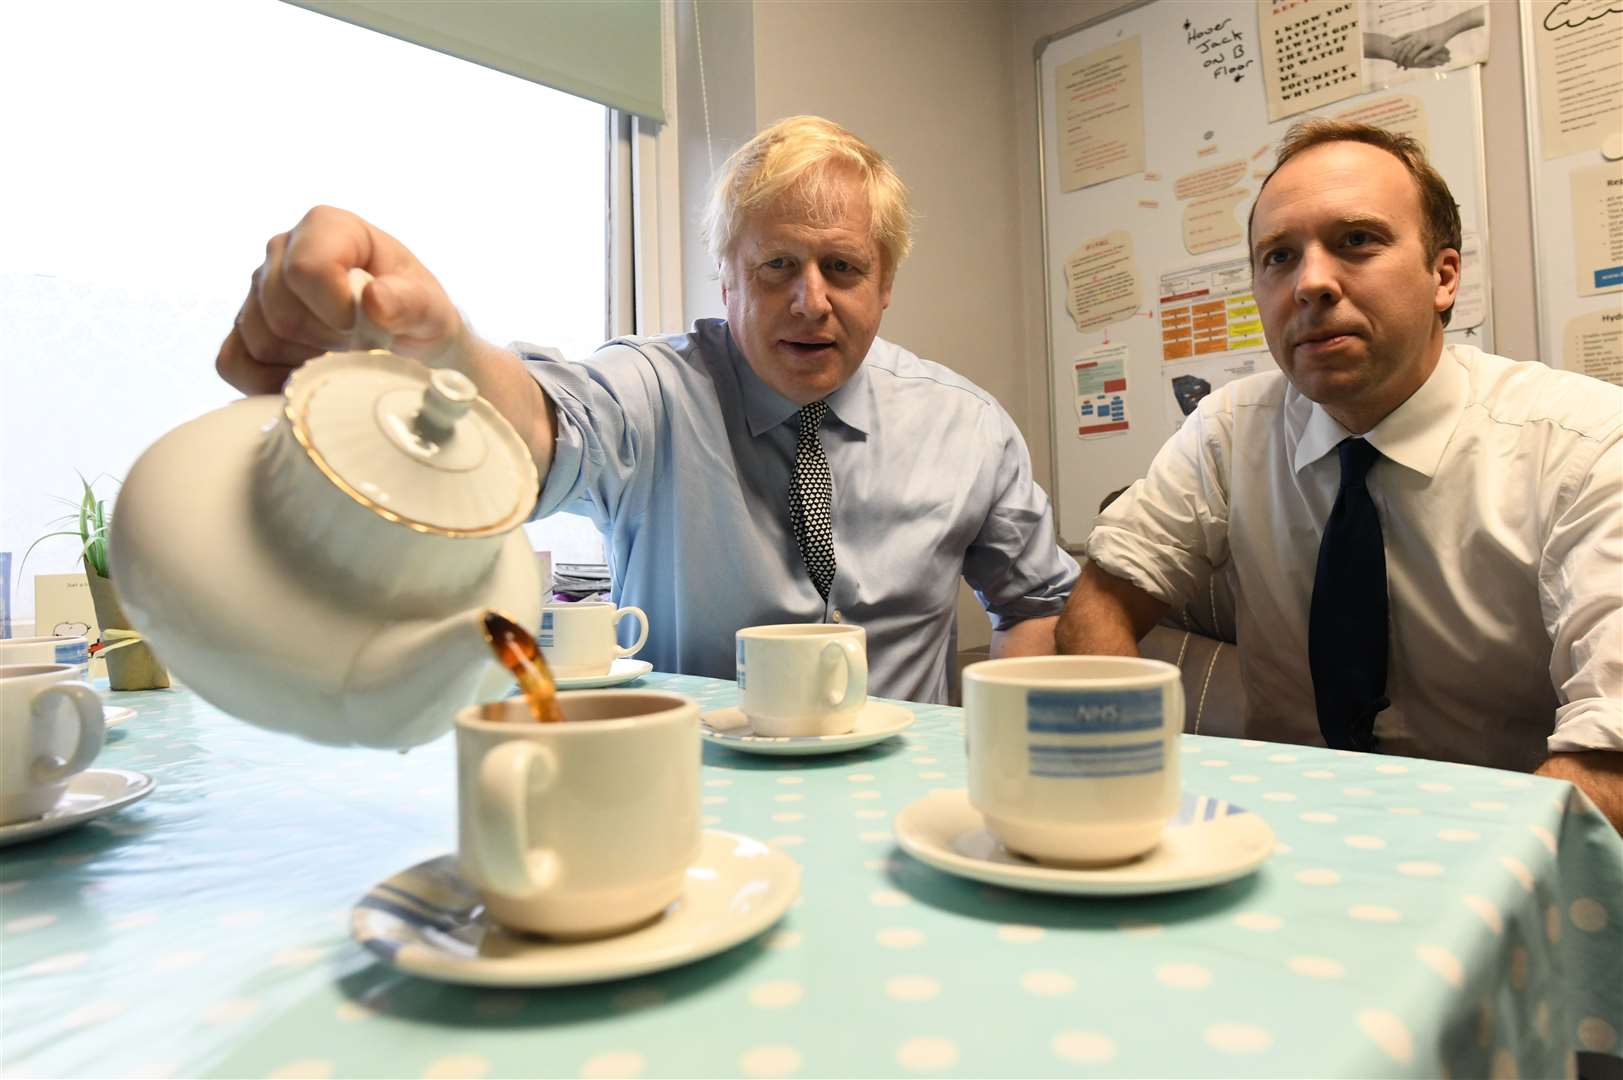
[{"left": 284, "top": 349, "right": 540, "bottom": 536}]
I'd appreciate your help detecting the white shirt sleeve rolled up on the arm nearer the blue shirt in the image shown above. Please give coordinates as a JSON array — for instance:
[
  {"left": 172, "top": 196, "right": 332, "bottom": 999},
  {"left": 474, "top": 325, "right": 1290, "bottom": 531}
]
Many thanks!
[{"left": 1087, "top": 396, "right": 1230, "bottom": 607}]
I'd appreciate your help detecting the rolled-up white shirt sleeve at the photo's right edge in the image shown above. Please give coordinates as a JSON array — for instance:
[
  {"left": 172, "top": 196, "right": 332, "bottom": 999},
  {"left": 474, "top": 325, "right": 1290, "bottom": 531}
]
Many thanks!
[{"left": 1539, "top": 432, "right": 1623, "bottom": 752}]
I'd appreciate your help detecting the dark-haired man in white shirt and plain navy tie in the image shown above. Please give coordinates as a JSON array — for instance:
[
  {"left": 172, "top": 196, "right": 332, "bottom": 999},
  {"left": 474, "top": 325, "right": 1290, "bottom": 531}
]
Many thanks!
[{"left": 1058, "top": 120, "right": 1623, "bottom": 828}]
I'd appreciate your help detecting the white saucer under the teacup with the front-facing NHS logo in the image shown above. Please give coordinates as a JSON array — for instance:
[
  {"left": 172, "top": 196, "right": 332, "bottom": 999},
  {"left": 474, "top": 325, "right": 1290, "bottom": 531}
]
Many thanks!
[{"left": 896, "top": 788, "right": 1274, "bottom": 896}]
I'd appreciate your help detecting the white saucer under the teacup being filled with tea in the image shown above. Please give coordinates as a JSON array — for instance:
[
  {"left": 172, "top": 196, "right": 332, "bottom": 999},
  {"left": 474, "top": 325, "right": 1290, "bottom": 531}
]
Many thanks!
[{"left": 349, "top": 830, "right": 800, "bottom": 986}]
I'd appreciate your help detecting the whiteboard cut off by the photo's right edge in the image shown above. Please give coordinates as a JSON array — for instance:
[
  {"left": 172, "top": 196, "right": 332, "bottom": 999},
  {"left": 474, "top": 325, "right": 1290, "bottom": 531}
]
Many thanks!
[{"left": 1521, "top": 3, "right": 1623, "bottom": 382}]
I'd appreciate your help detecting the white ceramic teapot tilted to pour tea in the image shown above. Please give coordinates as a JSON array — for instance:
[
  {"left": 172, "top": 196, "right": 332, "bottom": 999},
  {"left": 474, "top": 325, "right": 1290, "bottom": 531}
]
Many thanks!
[{"left": 109, "top": 271, "right": 542, "bottom": 747}]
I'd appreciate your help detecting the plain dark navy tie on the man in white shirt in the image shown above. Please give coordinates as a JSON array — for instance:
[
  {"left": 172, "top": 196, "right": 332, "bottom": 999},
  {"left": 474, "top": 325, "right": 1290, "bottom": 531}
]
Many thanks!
[{"left": 1308, "top": 438, "right": 1391, "bottom": 750}]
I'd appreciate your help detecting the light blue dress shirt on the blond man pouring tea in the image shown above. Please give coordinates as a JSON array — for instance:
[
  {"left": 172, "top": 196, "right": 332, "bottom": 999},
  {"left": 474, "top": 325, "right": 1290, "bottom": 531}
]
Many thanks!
[{"left": 514, "top": 320, "right": 1076, "bottom": 702}]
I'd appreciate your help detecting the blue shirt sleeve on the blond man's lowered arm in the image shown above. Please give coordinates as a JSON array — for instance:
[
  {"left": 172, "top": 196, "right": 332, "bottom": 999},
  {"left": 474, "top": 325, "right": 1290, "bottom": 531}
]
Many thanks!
[{"left": 964, "top": 404, "right": 1078, "bottom": 630}]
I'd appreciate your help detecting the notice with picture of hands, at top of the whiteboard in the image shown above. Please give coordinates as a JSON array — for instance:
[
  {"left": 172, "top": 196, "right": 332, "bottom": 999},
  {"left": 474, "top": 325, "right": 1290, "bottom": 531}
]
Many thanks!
[{"left": 1363, "top": 0, "right": 1488, "bottom": 86}]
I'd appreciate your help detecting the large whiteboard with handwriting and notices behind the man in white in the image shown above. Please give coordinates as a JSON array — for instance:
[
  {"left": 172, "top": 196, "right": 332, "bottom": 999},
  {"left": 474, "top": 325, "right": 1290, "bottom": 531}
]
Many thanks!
[{"left": 1035, "top": 0, "right": 1493, "bottom": 551}]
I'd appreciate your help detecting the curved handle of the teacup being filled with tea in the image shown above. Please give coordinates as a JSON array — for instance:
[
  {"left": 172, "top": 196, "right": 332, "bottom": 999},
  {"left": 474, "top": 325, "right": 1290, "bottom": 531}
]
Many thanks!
[{"left": 476, "top": 739, "right": 558, "bottom": 898}]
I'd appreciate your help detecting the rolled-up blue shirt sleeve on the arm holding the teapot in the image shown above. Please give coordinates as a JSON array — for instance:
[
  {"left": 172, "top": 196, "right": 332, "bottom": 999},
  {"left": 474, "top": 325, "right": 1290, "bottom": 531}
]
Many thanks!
[{"left": 511, "top": 343, "right": 661, "bottom": 526}]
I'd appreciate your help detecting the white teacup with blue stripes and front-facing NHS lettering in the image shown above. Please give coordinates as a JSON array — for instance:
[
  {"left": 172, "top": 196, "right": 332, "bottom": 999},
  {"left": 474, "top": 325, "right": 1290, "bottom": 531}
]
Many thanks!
[{"left": 964, "top": 656, "right": 1183, "bottom": 864}]
